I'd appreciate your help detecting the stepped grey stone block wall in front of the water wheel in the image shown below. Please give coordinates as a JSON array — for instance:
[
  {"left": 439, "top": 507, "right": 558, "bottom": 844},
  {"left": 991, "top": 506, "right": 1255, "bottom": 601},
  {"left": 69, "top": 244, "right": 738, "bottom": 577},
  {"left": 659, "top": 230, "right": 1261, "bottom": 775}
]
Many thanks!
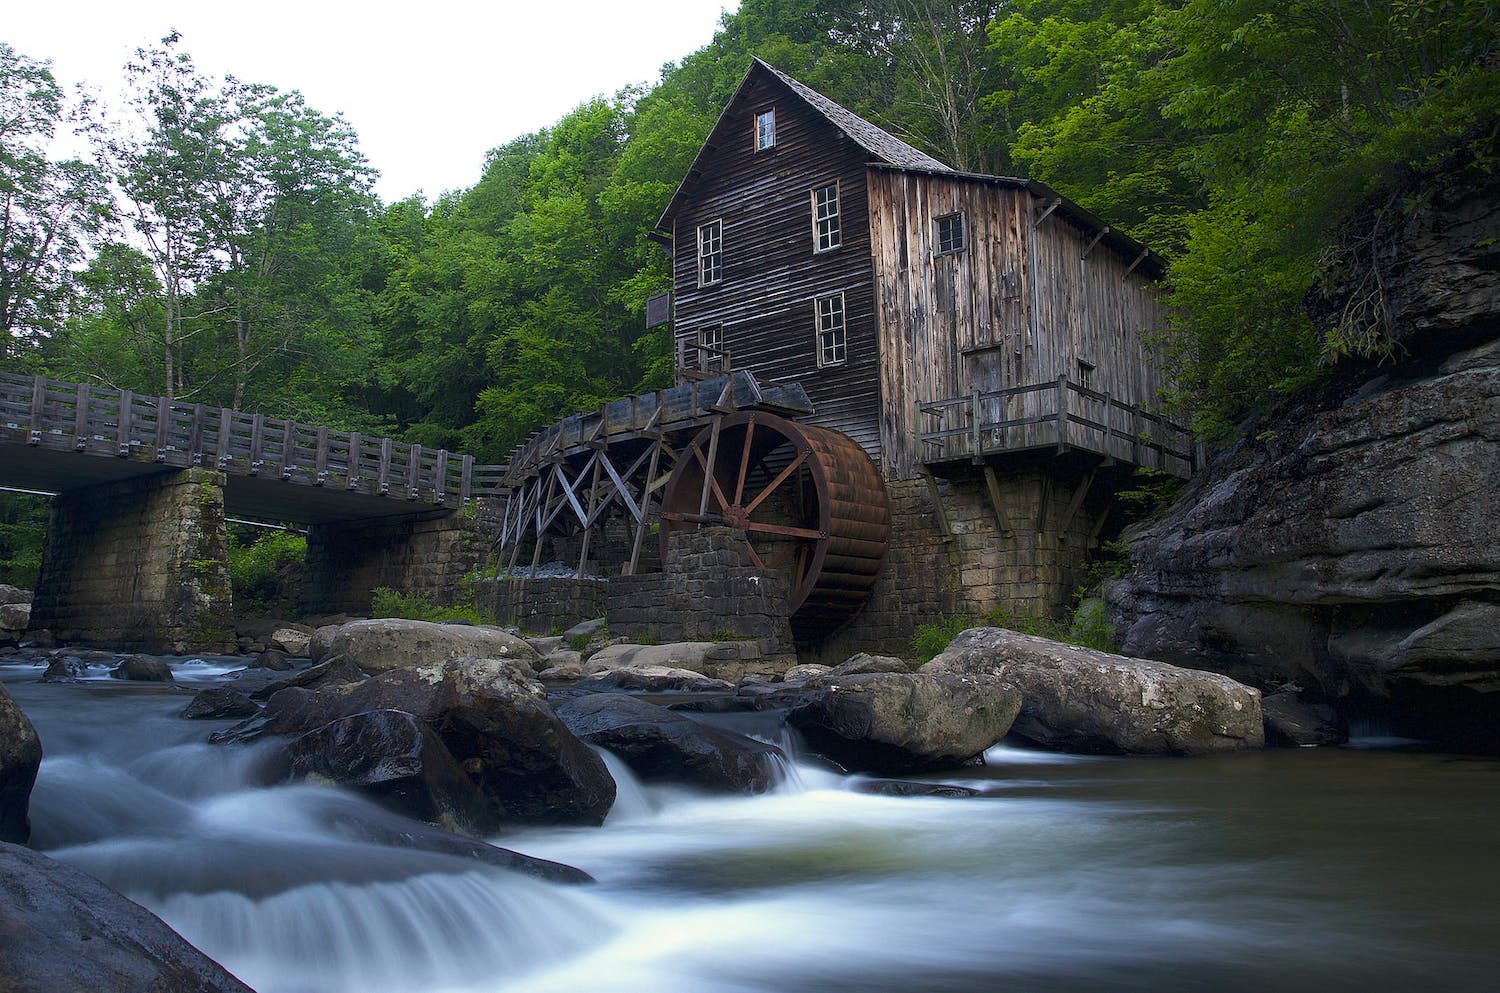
[{"left": 608, "top": 528, "right": 792, "bottom": 659}]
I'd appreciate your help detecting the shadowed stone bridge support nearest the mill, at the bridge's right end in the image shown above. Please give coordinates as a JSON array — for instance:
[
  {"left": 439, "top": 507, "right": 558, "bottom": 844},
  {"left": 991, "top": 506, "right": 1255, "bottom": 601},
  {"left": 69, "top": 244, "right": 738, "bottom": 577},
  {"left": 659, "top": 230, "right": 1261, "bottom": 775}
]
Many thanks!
[{"left": 303, "top": 512, "right": 480, "bottom": 617}]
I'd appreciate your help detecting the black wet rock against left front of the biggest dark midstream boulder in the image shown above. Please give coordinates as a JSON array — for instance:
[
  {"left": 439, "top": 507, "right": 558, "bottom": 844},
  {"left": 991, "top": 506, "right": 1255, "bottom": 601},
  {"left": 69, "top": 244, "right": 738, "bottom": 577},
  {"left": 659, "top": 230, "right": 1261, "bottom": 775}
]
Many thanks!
[{"left": 285, "top": 710, "right": 501, "bottom": 833}]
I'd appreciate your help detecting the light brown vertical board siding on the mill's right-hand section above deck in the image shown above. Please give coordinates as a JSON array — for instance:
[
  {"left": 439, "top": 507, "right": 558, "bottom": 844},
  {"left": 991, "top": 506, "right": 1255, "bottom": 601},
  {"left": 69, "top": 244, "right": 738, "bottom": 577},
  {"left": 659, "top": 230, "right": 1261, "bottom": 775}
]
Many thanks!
[{"left": 869, "top": 170, "right": 1163, "bottom": 479}]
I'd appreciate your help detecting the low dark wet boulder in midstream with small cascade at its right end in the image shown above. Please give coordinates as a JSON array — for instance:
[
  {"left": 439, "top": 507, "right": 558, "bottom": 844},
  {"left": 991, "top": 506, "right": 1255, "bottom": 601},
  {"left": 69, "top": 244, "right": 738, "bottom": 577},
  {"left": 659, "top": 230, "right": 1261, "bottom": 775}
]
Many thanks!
[{"left": 557, "top": 693, "right": 786, "bottom": 794}]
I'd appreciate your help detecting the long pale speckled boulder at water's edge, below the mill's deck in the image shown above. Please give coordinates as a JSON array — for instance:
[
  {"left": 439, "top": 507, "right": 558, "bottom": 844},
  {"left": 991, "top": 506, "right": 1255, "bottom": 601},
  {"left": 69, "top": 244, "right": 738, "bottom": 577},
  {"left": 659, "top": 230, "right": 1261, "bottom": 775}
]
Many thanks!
[{"left": 921, "top": 627, "right": 1265, "bottom": 755}]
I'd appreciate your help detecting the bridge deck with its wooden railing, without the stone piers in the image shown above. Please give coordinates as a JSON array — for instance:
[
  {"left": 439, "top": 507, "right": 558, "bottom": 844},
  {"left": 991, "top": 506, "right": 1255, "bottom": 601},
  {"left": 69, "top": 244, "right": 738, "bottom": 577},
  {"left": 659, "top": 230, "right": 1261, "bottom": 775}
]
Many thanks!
[{"left": 0, "top": 372, "right": 506, "bottom": 524}]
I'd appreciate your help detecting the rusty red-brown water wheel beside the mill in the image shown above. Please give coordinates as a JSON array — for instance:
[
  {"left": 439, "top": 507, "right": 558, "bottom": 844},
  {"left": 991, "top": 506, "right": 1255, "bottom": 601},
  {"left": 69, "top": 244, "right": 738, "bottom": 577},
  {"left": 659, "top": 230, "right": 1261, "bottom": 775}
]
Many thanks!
[{"left": 662, "top": 411, "right": 891, "bottom": 642}]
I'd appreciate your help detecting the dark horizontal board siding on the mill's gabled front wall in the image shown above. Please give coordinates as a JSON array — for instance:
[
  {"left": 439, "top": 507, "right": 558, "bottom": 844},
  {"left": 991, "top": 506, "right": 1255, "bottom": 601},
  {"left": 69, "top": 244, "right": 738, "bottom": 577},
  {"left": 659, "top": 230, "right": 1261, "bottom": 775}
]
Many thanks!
[{"left": 672, "top": 75, "right": 881, "bottom": 459}]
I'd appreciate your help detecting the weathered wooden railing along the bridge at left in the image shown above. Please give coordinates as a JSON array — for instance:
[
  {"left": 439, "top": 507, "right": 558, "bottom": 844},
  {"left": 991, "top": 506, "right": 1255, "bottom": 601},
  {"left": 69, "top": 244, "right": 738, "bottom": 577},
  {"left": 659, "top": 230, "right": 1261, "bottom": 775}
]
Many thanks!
[{"left": 0, "top": 372, "right": 506, "bottom": 507}]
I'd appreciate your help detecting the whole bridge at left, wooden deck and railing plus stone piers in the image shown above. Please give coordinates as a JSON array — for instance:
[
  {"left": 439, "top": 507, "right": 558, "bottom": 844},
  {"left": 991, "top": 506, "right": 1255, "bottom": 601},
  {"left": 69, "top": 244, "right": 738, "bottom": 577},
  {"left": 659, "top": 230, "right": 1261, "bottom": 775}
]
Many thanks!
[{"left": 0, "top": 372, "right": 504, "bottom": 651}]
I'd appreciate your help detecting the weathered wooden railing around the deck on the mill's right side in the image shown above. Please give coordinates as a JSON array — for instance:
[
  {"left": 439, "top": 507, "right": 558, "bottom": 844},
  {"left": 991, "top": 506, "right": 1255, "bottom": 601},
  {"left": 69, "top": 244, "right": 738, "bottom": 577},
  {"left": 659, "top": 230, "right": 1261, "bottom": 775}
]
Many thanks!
[{"left": 917, "top": 375, "right": 1196, "bottom": 477}]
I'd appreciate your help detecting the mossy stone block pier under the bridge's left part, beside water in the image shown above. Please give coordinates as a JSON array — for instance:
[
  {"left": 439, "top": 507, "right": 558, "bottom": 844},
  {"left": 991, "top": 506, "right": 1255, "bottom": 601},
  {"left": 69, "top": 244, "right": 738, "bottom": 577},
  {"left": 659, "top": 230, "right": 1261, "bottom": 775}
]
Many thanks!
[{"left": 30, "top": 468, "right": 234, "bottom": 653}]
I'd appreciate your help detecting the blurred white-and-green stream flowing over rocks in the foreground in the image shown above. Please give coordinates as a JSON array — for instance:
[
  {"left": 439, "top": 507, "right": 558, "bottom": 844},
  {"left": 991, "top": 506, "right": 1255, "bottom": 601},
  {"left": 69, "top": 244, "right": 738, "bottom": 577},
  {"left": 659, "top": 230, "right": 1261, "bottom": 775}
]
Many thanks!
[{"left": 0, "top": 659, "right": 1500, "bottom": 993}]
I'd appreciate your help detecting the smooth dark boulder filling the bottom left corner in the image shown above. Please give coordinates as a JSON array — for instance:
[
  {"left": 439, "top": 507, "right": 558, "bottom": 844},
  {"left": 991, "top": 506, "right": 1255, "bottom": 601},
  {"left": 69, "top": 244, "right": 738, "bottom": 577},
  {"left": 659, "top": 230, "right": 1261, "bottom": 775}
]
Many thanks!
[{"left": 0, "top": 845, "right": 255, "bottom": 993}]
